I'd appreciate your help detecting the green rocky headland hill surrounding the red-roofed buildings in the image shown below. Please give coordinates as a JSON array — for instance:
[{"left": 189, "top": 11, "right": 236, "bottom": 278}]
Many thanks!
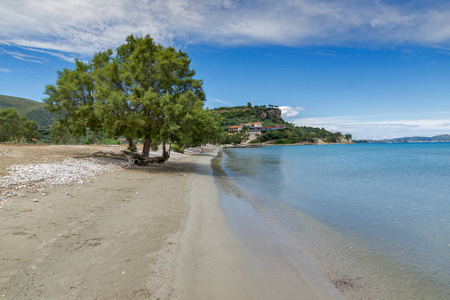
[{"left": 212, "top": 103, "right": 352, "bottom": 144}]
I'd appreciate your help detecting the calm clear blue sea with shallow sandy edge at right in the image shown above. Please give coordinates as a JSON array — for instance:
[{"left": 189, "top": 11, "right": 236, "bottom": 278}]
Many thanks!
[{"left": 213, "top": 143, "right": 450, "bottom": 299}]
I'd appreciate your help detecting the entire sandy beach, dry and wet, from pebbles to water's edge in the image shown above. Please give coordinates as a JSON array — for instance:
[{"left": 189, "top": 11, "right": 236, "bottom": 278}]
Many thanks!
[{"left": 0, "top": 145, "right": 341, "bottom": 299}]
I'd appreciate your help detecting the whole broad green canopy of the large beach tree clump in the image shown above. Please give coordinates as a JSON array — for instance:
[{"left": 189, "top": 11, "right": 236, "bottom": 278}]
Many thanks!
[{"left": 44, "top": 35, "right": 220, "bottom": 162}]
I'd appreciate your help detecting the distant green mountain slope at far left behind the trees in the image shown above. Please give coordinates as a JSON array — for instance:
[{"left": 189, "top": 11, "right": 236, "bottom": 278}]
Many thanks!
[{"left": 0, "top": 95, "right": 54, "bottom": 126}]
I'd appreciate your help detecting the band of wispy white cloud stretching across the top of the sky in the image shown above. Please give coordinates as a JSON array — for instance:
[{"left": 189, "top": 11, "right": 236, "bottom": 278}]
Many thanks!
[{"left": 0, "top": 0, "right": 450, "bottom": 55}]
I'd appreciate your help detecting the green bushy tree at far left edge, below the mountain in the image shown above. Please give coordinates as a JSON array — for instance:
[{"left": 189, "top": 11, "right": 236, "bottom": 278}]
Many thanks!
[{"left": 0, "top": 108, "right": 39, "bottom": 143}]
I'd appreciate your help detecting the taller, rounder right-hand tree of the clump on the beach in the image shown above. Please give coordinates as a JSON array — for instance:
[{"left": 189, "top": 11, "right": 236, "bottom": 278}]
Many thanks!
[{"left": 94, "top": 35, "right": 210, "bottom": 157}]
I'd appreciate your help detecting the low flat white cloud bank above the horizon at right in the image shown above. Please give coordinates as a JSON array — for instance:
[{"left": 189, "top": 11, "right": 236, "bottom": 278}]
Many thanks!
[{"left": 293, "top": 113, "right": 450, "bottom": 140}]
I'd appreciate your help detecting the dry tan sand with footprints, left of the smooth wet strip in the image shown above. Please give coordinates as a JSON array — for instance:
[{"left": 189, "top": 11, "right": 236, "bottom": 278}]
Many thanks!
[{"left": 0, "top": 147, "right": 197, "bottom": 299}]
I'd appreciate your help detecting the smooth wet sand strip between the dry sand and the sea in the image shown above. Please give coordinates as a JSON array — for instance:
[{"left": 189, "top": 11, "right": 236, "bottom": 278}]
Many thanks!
[{"left": 166, "top": 149, "right": 344, "bottom": 300}]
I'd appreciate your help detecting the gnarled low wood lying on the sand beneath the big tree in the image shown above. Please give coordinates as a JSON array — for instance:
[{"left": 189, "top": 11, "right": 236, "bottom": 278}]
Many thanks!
[{"left": 72, "top": 150, "right": 170, "bottom": 166}]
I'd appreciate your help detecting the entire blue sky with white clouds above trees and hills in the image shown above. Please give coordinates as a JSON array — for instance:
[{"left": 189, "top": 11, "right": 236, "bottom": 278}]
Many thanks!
[{"left": 0, "top": 0, "right": 450, "bottom": 140}]
